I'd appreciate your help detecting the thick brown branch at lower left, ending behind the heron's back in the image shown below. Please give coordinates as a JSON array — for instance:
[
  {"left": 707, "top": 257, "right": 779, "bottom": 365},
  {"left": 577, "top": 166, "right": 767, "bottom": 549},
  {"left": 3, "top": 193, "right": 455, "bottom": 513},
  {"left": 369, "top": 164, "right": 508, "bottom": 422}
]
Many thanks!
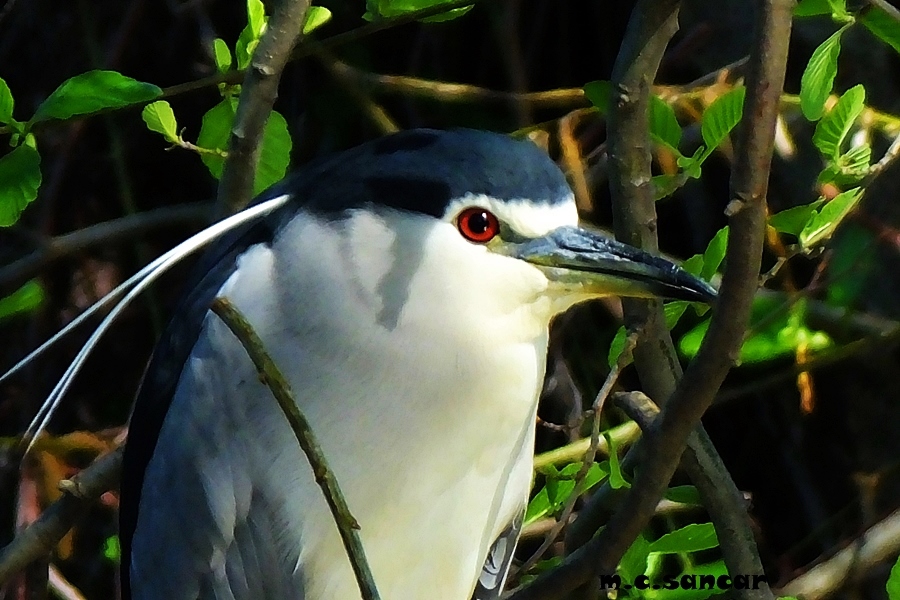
[{"left": 0, "top": 446, "right": 123, "bottom": 585}]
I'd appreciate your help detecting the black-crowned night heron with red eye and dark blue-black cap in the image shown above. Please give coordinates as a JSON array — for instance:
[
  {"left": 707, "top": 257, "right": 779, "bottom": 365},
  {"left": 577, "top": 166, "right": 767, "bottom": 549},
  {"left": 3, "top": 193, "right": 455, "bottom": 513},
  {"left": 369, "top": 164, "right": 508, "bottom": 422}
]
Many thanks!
[{"left": 8, "top": 130, "right": 715, "bottom": 600}]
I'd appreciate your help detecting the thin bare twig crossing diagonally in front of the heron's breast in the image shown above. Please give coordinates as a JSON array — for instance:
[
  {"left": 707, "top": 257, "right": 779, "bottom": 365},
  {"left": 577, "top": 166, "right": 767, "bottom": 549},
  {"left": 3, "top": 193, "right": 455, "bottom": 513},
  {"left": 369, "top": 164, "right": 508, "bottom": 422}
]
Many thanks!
[{"left": 211, "top": 298, "right": 380, "bottom": 600}]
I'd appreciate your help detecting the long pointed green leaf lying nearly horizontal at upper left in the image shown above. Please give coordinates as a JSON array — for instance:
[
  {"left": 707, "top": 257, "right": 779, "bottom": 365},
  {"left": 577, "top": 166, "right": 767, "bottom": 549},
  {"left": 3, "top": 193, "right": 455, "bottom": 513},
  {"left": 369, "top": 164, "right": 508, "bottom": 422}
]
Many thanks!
[{"left": 31, "top": 71, "right": 162, "bottom": 123}]
